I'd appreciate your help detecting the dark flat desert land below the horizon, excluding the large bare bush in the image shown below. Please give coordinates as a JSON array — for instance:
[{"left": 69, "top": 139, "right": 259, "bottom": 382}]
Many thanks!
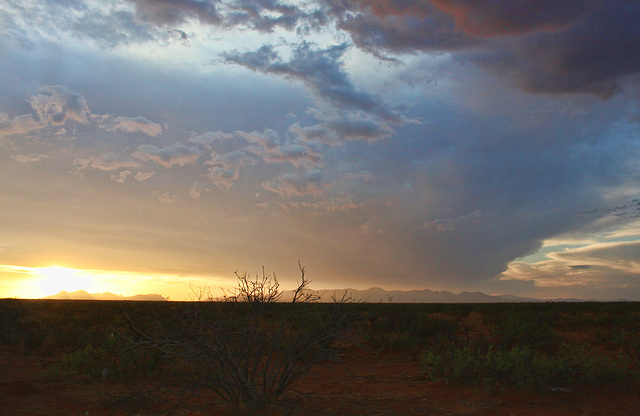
[{"left": 0, "top": 300, "right": 640, "bottom": 416}]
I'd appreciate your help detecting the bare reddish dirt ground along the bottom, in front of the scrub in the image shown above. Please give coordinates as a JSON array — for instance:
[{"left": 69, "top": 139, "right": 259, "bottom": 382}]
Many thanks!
[{"left": 0, "top": 348, "right": 640, "bottom": 416}]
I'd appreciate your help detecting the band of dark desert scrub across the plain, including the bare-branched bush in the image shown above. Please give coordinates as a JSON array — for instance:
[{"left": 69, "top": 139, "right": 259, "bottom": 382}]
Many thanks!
[{"left": 0, "top": 292, "right": 640, "bottom": 415}]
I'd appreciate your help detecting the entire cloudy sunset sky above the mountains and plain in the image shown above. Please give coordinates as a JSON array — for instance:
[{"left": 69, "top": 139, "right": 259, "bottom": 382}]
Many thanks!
[{"left": 0, "top": 0, "right": 640, "bottom": 300}]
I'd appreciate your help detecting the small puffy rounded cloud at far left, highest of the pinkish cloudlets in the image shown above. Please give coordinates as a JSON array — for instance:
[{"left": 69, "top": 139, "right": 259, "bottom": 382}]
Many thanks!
[{"left": 30, "top": 85, "right": 90, "bottom": 125}]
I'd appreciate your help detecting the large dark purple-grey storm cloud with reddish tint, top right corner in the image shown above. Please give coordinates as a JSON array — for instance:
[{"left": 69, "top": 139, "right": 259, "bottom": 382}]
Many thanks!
[{"left": 324, "top": 0, "right": 640, "bottom": 98}]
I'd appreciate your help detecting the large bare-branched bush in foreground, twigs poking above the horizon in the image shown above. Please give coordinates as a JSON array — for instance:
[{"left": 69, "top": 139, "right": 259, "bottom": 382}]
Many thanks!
[{"left": 131, "top": 266, "right": 353, "bottom": 415}]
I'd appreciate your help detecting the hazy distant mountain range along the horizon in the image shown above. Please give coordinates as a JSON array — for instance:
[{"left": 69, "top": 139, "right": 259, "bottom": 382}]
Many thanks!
[{"left": 43, "top": 287, "right": 612, "bottom": 303}]
